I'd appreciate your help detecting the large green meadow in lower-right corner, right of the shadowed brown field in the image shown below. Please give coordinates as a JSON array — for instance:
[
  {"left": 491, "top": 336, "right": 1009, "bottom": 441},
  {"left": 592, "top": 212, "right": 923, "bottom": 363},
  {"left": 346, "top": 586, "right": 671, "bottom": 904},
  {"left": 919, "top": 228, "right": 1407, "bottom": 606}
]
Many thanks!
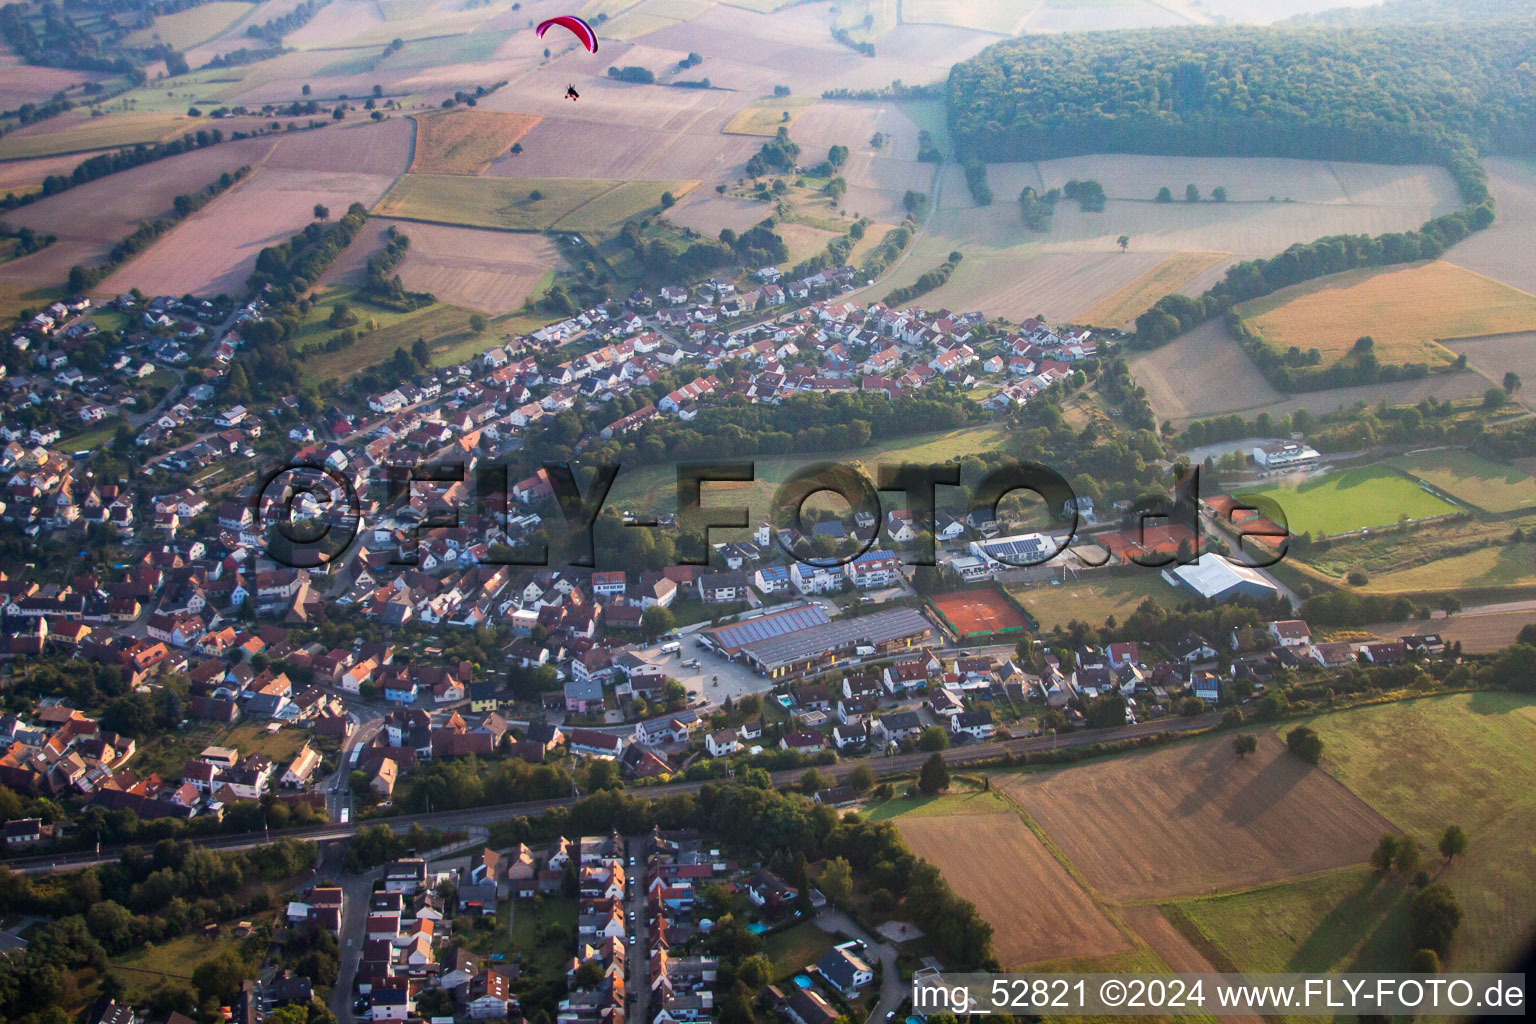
[{"left": 1284, "top": 692, "right": 1536, "bottom": 970}]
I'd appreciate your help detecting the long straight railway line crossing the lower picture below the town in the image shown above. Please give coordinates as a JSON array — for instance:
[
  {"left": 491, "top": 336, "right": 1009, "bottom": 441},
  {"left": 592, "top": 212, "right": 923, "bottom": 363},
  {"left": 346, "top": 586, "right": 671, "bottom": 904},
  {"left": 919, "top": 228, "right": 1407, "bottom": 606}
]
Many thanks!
[{"left": 0, "top": 712, "right": 1221, "bottom": 875}]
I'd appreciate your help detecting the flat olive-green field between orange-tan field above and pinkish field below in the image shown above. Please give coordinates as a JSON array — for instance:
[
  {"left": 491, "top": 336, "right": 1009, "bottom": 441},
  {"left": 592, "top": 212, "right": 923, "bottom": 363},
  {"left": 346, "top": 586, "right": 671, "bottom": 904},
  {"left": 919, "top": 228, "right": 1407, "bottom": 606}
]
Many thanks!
[{"left": 373, "top": 173, "right": 699, "bottom": 232}]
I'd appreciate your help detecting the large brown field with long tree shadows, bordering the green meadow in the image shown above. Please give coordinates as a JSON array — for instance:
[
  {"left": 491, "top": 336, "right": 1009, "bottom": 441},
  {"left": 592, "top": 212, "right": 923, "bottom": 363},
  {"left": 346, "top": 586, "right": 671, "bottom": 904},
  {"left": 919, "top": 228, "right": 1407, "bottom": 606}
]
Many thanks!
[{"left": 997, "top": 731, "right": 1390, "bottom": 900}]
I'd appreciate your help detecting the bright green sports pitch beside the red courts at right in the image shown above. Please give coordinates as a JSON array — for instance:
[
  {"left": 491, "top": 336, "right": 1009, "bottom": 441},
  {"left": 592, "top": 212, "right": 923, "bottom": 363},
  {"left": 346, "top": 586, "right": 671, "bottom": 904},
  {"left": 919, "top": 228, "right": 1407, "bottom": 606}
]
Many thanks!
[{"left": 1236, "top": 465, "right": 1456, "bottom": 536}]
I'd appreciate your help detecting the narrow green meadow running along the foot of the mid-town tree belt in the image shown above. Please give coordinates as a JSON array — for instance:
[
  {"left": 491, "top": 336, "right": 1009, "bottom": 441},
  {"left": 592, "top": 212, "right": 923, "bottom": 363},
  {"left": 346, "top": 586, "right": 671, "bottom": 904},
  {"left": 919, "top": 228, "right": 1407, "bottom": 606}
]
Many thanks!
[{"left": 608, "top": 425, "right": 1006, "bottom": 521}]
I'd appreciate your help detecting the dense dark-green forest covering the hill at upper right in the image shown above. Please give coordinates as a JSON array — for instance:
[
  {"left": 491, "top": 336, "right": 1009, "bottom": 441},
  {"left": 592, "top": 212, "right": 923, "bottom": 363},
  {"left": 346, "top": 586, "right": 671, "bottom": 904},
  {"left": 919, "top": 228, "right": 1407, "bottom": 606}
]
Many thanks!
[{"left": 946, "top": 15, "right": 1536, "bottom": 206}]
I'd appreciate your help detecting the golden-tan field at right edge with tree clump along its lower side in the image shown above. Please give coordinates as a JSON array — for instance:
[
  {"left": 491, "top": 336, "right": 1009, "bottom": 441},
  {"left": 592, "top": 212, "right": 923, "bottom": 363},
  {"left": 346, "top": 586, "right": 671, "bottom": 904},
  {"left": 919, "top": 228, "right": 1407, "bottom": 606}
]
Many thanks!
[{"left": 1235, "top": 261, "right": 1536, "bottom": 367}]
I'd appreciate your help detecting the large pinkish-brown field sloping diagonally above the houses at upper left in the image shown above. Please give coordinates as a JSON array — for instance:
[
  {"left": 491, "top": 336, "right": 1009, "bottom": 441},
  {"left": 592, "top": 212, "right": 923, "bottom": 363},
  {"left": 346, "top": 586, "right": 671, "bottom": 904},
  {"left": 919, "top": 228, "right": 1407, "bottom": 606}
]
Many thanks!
[{"left": 100, "top": 167, "right": 390, "bottom": 295}]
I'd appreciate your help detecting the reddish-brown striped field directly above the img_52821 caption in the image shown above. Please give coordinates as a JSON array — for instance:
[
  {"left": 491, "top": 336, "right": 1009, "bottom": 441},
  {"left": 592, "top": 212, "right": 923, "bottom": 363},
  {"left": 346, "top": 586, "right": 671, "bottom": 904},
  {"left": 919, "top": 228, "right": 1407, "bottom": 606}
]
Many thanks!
[{"left": 895, "top": 814, "right": 1130, "bottom": 970}]
